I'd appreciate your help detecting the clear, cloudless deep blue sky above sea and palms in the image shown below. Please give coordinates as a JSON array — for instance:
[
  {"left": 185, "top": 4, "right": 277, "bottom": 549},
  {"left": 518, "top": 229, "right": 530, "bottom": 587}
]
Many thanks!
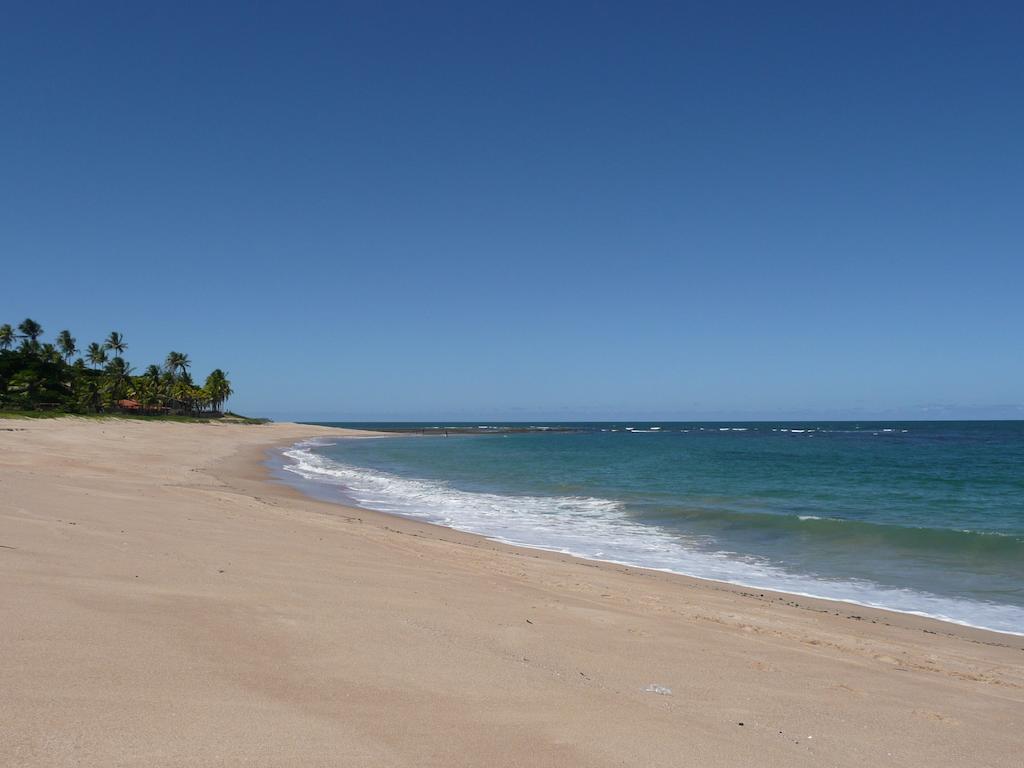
[{"left": 0, "top": 2, "right": 1024, "bottom": 420}]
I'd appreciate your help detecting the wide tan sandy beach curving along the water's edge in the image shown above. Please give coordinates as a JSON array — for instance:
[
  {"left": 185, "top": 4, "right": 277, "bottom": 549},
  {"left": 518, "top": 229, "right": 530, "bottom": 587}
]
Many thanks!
[{"left": 0, "top": 418, "right": 1024, "bottom": 768}]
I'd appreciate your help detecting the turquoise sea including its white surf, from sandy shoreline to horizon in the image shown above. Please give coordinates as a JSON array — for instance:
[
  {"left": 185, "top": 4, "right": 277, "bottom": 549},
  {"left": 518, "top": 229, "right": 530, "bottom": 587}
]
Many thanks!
[{"left": 274, "top": 422, "right": 1024, "bottom": 633}]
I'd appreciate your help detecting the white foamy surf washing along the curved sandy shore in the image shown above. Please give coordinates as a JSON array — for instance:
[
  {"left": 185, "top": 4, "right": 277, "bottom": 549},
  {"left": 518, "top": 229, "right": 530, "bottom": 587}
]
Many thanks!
[{"left": 283, "top": 441, "right": 1024, "bottom": 635}]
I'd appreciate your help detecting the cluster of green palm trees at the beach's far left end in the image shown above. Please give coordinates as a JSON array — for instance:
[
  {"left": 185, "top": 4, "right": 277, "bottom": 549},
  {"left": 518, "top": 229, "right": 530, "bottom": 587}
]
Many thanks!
[{"left": 0, "top": 317, "right": 233, "bottom": 416}]
